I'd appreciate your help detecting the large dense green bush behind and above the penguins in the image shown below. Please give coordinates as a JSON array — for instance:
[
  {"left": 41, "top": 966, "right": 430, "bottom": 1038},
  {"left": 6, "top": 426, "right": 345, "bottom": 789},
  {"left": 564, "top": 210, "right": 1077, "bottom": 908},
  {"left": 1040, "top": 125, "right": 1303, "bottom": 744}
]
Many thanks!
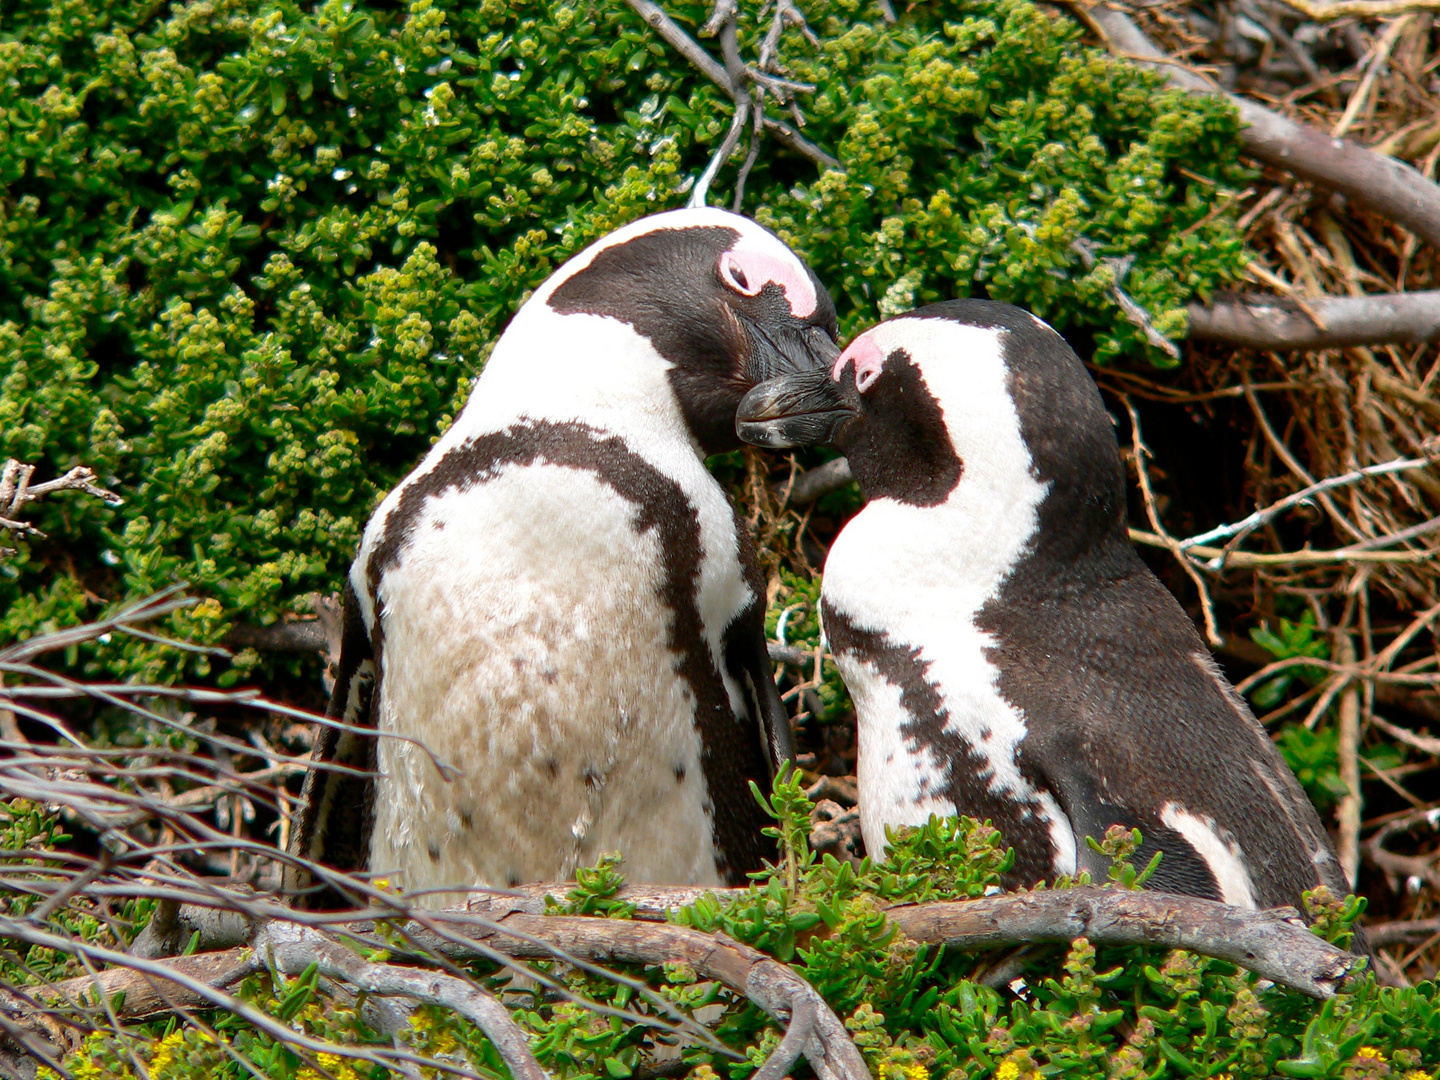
[{"left": 0, "top": 0, "right": 1244, "bottom": 680}]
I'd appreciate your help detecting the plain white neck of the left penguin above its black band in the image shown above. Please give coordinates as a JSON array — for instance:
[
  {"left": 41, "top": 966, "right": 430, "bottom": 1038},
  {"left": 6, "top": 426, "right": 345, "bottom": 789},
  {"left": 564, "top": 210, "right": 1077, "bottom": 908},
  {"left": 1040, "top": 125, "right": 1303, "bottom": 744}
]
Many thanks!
[{"left": 441, "top": 300, "right": 703, "bottom": 461}]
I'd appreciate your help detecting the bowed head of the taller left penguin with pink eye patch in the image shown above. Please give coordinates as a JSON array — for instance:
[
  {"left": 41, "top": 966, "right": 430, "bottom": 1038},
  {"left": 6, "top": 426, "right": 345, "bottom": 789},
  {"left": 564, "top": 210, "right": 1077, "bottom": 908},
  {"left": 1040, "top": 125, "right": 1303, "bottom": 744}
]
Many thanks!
[{"left": 526, "top": 207, "right": 840, "bottom": 454}]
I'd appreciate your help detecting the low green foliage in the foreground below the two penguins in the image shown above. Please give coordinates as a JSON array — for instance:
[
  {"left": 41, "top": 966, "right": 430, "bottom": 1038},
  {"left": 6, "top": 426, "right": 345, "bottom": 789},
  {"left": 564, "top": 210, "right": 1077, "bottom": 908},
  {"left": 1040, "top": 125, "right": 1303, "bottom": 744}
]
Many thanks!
[{"left": 19, "top": 780, "right": 1440, "bottom": 1080}]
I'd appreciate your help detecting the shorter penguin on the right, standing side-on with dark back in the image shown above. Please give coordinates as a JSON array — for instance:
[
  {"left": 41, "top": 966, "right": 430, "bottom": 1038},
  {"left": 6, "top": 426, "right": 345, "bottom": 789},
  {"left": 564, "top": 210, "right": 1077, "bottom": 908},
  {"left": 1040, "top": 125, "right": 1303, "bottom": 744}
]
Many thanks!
[{"left": 737, "top": 300, "right": 1348, "bottom": 907}]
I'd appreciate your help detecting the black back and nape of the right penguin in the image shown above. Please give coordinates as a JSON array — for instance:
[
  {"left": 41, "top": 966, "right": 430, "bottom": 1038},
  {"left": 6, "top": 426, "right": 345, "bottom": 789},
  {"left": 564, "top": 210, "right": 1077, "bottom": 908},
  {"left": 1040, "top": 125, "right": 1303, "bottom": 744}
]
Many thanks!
[{"left": 841, "top": 300, "right": 1348, "bottom": 907}]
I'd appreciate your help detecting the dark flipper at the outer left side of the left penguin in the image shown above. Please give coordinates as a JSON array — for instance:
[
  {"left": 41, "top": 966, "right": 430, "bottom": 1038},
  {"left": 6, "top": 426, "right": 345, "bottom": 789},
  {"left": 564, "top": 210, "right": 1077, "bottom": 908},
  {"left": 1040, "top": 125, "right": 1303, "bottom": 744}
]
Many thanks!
[{"left": 285, "top": 585, "right": 377, "bottom": 907}]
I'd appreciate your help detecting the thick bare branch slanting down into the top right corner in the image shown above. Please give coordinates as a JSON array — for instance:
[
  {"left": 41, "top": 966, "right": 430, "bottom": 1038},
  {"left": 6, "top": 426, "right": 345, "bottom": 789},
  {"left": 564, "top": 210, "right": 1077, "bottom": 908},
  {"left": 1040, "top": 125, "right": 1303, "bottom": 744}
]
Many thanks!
[{"left": 1084, "top": 3, "right": 1440, "bottom": 245}]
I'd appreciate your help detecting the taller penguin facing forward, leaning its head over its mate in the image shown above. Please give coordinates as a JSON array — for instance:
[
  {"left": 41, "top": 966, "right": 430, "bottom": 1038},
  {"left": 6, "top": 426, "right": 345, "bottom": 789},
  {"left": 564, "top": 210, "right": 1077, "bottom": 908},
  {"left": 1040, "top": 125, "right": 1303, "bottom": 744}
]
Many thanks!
[{"left": 291, "top": 209, "right": 840, "bottom": 904}]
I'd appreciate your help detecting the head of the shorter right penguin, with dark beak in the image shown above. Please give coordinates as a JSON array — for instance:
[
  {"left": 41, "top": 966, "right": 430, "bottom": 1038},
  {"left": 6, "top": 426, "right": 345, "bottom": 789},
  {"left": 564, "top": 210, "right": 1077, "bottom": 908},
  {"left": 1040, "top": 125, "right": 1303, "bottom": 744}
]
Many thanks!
[{"left": 736, "top": 300, "right": 1125, "bottom": 533}]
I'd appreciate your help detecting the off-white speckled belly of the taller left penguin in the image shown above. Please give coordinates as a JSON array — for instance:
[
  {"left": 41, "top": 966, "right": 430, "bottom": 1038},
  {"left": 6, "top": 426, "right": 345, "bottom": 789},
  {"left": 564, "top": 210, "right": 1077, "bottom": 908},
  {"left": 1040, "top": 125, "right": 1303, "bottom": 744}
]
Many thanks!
[{"left": 370, "top": 464, "right": 749, "bottom": 903}]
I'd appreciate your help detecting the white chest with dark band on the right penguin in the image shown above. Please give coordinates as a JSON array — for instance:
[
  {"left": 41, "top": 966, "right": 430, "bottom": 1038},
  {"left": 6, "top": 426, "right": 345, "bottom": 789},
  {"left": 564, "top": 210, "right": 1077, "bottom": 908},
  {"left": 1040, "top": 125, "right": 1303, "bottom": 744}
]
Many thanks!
[{"left": 824, "top": 501, "right": 1076, "bottom": 873}]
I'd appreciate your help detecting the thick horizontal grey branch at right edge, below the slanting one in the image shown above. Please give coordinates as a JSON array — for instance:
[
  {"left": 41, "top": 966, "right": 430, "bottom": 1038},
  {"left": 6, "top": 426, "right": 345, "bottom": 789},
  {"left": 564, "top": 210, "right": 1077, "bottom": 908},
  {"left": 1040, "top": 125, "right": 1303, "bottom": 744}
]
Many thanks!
[{"left": 1189, "top": 292, "right": 1440, "bottom": 351}]
